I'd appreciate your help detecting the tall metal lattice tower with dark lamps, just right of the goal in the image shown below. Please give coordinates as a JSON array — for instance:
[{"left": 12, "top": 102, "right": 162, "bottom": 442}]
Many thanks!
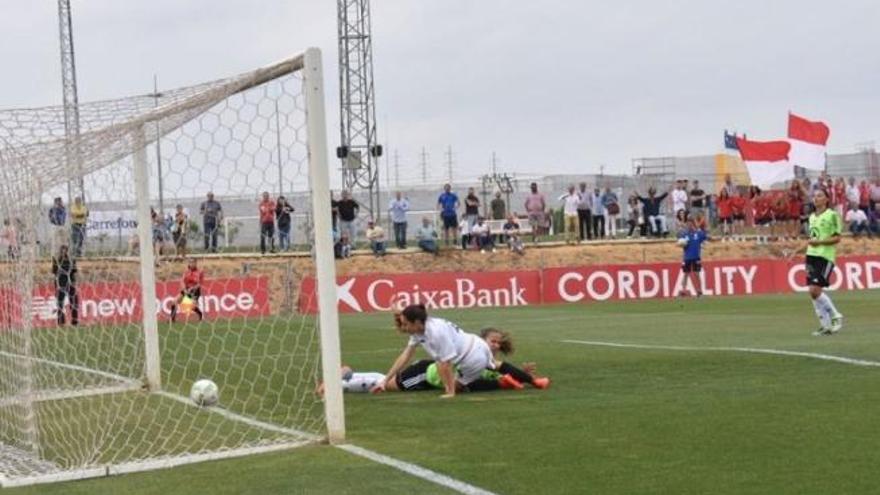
[{"left": 336, "top": 0, "right": 382, "bottom": 217}]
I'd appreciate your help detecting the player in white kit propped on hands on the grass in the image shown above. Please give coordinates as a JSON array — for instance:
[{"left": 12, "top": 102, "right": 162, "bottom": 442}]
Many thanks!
[{"left": 373, "top": 304, "right": 495, "bottom": 398}]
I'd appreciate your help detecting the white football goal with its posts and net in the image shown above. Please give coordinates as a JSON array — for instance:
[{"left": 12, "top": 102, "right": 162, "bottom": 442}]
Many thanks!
[{"left": 0, "top": 49, "right": 344, "bottom": 486}]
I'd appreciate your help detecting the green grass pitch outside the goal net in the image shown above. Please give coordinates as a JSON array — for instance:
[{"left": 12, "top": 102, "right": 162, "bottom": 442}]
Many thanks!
[{"left": 7, "top": 291, "right": 880, "bottom": 495}]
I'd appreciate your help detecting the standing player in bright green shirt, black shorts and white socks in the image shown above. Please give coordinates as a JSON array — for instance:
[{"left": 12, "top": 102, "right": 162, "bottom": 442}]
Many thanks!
[{"left": 806, "top": 189, "right": 843, "bottom": 336}]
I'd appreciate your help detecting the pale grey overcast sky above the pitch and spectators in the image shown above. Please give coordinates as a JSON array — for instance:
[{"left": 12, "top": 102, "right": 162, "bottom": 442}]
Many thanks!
[{"left": 0, "top": 0, "right": 880, "bottom": 184}]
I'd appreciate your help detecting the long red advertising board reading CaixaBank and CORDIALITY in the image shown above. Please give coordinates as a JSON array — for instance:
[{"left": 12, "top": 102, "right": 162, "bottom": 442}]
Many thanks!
[{"left": 299, "top": 256, "right": 880, "bottom": 313}]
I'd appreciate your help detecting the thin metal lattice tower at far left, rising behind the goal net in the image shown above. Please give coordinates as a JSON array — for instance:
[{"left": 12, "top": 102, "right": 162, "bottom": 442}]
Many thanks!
[{"left": 58, "top": 0, "right": 86, "bottom": 204}]
